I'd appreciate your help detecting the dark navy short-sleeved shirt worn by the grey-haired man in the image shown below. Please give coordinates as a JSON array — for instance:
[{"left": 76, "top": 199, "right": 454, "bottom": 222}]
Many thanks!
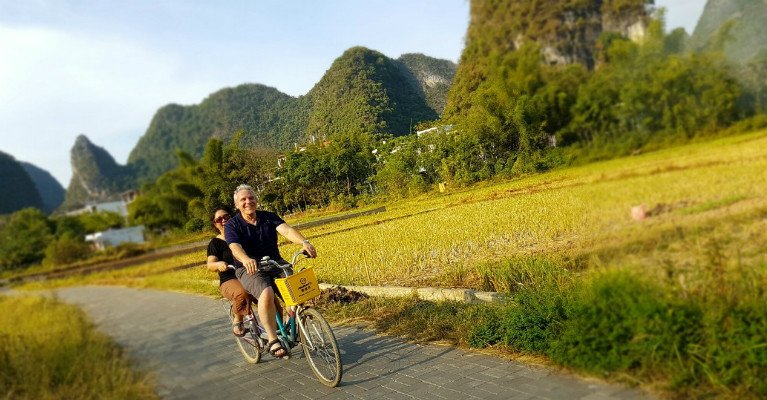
[{"left": 224, "top": 211, "right": 285, "bottom": 267}]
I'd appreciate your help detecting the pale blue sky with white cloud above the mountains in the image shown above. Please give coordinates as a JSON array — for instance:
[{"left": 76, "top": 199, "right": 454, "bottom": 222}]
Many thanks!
[{"left": 0, "top": 0, "right": 705, "bottom": 187}]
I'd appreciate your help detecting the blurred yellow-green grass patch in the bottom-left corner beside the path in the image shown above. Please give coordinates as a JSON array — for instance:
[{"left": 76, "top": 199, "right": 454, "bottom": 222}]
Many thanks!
[{"left": 0, "top": 297, "right": 157, "bottom": 399}]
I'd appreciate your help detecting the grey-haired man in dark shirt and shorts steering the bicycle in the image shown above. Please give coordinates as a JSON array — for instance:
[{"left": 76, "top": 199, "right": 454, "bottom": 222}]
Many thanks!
[{"left": 224, "top": 185, "right": 317, "bottom": 358}]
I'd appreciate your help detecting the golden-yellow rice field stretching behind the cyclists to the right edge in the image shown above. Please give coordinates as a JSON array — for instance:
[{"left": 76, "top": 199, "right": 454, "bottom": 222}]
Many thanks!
[{"left": 18, "top": 131, "right": 767, "bottom": 294}]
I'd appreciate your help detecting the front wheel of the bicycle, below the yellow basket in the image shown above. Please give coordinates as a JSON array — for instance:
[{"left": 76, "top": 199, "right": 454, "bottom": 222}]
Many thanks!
[{"left": 298, "top": 308, "right": 343, "bottom": 387}]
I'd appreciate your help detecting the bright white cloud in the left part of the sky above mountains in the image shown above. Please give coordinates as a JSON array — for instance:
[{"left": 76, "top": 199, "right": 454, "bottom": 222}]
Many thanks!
[{"left": 0, "top": 26, "right": 217, "bottom": 186}]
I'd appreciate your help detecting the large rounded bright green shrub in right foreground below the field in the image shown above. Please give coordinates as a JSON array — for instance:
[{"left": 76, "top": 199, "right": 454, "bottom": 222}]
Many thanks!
[{"left": 549, "top": 270, "right": 702, "bottom": 374}]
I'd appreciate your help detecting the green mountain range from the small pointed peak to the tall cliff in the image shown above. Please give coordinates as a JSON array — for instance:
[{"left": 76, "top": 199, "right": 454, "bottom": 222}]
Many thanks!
[{"left": 63, "top": 47, "right": 456, "bottom": 209}]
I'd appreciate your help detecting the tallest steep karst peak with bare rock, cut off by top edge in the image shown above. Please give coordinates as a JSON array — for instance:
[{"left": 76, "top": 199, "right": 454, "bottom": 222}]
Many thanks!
[{"left": 445, "top": 0, "right": 652, "bottom": 118}]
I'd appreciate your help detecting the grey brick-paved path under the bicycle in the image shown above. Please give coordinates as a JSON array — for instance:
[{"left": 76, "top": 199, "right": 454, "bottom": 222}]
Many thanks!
[{"left": 57, "top": 286, "right": 648, "bottom": 400}]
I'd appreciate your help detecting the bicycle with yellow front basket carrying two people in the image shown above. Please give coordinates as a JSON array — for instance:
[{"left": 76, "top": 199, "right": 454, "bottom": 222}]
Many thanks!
[{"left": 222, "top": 251, "right": 343, "bottom": 387}]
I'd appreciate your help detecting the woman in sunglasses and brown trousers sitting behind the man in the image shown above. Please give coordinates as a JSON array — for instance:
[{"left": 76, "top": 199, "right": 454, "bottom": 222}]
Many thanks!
[{"left": 207, "top": 206, "right": 250, "bottom": 337}]
